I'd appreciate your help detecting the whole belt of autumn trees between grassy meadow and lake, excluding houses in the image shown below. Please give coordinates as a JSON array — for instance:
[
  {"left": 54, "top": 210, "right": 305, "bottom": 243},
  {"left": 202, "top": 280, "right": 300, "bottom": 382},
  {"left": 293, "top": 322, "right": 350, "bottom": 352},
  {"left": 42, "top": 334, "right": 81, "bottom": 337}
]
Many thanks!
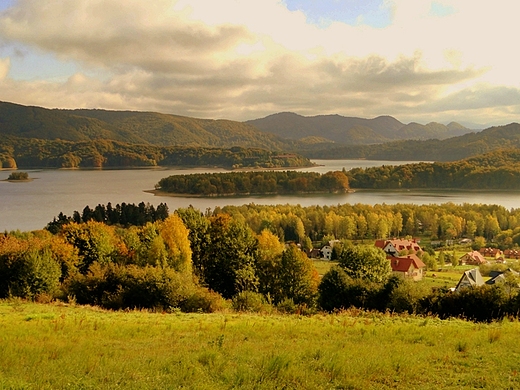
[{"left": 0, "top": 198, "right": 520, "bottom": 321}]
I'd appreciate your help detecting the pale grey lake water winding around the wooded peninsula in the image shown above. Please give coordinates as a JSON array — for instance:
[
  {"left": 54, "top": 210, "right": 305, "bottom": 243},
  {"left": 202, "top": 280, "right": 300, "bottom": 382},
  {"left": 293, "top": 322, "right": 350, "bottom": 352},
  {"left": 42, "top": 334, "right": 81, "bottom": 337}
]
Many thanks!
[{"left": 0, "top": 160, "right": 520, "bottom": 231}]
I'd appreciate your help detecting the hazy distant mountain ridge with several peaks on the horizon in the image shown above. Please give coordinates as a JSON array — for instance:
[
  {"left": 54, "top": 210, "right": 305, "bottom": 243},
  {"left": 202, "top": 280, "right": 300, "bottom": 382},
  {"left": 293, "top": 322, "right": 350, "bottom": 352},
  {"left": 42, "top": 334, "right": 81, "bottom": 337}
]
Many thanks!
[{"left": 245, "top": 112, "right": 472, "bottom": 145}]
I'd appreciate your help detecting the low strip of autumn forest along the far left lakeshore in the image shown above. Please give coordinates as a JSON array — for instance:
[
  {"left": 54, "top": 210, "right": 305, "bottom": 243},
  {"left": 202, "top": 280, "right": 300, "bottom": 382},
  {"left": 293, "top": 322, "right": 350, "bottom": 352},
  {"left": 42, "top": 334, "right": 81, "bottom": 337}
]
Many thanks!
[{"left": 0, "top": 136, "right": 313, "bottom": 169}]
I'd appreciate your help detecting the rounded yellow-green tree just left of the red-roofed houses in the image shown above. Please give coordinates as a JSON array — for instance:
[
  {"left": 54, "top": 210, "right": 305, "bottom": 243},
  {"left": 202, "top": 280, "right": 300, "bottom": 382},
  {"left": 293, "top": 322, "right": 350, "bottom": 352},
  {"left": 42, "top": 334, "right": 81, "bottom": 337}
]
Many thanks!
[{"left": 338, "top": 246, "right": 392, "bottom": 283}]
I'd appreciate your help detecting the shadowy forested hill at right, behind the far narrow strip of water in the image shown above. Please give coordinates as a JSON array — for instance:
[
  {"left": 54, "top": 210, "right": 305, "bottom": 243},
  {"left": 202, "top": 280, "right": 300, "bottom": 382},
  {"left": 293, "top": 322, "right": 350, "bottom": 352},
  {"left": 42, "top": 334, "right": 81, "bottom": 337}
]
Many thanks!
[{"left": 304, "top": 123, "right": 520, "bottom": 161}]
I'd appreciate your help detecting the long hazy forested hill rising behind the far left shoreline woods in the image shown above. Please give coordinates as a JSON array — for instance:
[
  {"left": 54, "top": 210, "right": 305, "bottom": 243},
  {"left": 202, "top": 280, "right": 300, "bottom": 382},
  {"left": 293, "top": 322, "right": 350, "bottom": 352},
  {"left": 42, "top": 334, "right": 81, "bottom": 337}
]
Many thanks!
[{"left": 0, "top": 102, "right": 294, "bottom": 150}]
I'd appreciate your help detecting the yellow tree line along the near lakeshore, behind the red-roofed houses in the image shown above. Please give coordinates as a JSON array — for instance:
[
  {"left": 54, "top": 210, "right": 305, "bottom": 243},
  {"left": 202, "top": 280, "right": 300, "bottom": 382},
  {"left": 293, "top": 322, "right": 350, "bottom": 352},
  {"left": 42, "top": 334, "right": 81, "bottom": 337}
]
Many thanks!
[{"left": 214, "top": 203, "right": 520, "bottom": 249}]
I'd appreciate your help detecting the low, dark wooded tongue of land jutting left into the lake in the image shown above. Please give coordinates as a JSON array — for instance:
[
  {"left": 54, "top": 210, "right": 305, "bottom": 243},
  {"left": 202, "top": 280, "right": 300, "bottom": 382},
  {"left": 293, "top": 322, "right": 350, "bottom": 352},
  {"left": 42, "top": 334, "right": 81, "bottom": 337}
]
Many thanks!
[{"left": 155, "top": 171, "right": 349, "bottom": 196}]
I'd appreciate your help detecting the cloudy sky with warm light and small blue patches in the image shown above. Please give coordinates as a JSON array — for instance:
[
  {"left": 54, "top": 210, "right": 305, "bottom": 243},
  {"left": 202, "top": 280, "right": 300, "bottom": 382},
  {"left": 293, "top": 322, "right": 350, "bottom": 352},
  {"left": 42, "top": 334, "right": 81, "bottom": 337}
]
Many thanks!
[{"left": 0, "top": 0, "right": 520, "bottom": 126}]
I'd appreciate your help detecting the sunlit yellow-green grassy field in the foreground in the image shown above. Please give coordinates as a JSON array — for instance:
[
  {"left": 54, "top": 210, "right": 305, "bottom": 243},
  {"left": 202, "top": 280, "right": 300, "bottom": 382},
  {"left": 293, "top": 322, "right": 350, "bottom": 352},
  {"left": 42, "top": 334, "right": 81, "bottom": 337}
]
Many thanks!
[{"left": 0, "top": 300, "right": 520, "bottom": 389}]
